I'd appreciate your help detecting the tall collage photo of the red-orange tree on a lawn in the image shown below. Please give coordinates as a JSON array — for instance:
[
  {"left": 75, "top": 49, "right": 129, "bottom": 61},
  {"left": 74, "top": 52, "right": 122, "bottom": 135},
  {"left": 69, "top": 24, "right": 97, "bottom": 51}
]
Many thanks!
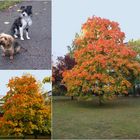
[{"left": 52, "top": 0, "right": 140, "bottom": 140}]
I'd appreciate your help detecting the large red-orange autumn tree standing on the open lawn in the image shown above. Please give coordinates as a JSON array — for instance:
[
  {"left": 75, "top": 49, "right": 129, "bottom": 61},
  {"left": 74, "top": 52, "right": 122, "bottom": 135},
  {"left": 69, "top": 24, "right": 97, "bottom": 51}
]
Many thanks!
[{"left": 63, "top": 17, "right": 140, "bottom": 103}]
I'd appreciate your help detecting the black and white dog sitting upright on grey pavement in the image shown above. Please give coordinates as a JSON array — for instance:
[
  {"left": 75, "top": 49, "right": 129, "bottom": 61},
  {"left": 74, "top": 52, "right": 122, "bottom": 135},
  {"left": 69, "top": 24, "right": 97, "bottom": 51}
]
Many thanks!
[{"left": 11, "top": 6, "right": 32, "bottom": 40}]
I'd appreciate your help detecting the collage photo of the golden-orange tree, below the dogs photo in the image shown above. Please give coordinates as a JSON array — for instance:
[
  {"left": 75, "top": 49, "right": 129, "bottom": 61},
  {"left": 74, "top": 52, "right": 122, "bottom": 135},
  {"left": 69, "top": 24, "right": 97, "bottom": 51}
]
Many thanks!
[{"left": 0, "top": 70, "right": 52, "bottom": 139}]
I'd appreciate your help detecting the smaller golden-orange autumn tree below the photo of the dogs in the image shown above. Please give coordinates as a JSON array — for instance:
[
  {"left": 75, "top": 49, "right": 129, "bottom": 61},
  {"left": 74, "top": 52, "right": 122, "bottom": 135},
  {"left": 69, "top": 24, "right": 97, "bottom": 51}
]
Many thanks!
[{"left": 0, "top": 74, "right": 51, "bottom": 136}]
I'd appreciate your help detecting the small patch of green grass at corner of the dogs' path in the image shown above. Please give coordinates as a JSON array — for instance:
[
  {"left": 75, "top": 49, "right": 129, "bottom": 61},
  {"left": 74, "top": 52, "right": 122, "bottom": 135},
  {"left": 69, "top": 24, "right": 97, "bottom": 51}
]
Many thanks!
[{"left": 0, "top": 0, "right": 22, "bottom": 10}]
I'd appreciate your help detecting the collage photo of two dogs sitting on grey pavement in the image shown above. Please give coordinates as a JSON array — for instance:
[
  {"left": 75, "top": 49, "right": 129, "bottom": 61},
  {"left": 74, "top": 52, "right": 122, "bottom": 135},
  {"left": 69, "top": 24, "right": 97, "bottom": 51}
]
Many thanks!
[{"left": 0, "top": 0, "right": 51, "bottom": 70}]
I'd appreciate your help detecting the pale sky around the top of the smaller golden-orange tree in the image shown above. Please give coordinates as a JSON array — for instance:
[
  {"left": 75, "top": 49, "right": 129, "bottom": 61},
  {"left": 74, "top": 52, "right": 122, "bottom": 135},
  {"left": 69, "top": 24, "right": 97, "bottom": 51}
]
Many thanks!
[{"left": 0, "top": 70, "right": 52, "bottom": 95}]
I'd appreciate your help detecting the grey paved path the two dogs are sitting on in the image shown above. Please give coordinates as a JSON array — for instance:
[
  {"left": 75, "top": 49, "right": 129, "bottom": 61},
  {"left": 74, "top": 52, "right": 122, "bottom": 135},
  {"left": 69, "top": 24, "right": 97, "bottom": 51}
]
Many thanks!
[{"left": 0, "top": 1, "right": 51, "bottom": 69}]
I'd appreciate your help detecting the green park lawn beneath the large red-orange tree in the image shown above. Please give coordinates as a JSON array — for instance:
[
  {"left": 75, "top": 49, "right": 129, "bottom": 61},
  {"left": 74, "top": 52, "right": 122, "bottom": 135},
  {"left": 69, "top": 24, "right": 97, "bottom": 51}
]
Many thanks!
[{"left": 52, "top": 97, "right": 140, "bottom": 139}]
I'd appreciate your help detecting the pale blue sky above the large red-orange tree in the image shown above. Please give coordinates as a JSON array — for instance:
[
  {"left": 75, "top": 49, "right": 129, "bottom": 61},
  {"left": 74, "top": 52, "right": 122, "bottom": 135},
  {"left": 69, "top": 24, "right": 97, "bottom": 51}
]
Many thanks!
[{"left": 52, "top": 0, "right": 140, "bottom": 63}]
